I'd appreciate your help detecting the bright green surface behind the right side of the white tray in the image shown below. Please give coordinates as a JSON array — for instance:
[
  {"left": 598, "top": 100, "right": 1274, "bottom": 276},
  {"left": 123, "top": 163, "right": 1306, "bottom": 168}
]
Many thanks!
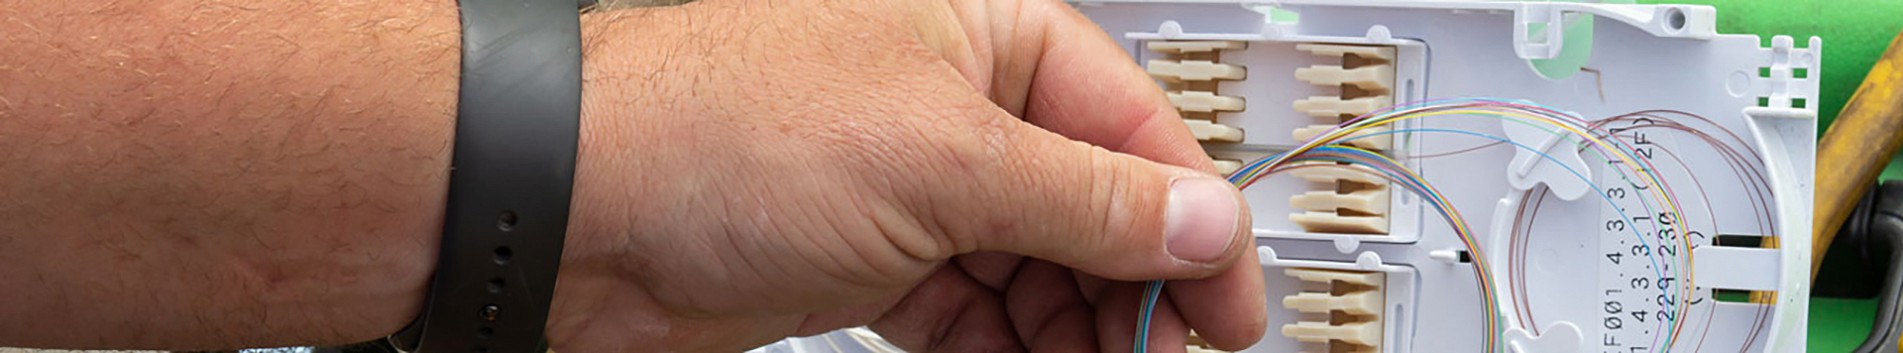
[{"left": 1640, "top": 0, "right": 1903, "bottom": 353}]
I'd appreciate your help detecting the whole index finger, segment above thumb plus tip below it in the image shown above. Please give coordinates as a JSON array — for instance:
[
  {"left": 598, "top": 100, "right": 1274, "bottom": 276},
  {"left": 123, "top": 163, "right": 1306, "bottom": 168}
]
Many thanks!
[{"left": 999, "top": 0, "right": 1267, "bottom": 349}]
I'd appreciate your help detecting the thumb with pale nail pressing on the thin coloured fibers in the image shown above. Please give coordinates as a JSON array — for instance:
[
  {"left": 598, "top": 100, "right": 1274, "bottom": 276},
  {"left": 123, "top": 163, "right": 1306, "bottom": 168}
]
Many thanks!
[{"left": 947, "top": 118, "right": 1250, "bottom": 280}]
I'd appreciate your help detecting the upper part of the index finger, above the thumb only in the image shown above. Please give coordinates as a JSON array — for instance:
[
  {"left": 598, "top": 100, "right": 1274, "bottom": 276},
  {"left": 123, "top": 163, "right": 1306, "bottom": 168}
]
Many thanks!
[{"left": 991, "top": 0, "right": 1214, "bottom": 172}]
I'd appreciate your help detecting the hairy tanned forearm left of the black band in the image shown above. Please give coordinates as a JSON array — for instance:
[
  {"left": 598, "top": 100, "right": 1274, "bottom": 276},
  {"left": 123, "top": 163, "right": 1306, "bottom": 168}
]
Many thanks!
[{"left": 0, "top": 0, "right": 461, "bottom": 349}]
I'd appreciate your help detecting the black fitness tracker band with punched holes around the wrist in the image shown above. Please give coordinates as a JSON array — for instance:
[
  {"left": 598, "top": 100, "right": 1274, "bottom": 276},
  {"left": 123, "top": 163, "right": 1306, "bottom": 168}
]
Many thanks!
[{"left": 390, "top": 0, "right": 582, "bottom": 353}]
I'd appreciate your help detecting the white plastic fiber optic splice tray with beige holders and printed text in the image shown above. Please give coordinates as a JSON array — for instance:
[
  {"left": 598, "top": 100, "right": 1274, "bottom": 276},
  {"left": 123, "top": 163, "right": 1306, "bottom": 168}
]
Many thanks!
[{"left": 1073, "top": 0, "right": 1823, "bottom": 353}]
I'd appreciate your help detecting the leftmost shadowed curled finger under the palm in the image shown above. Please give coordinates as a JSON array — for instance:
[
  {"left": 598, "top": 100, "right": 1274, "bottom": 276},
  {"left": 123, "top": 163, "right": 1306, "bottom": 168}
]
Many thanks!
[{"left": 870, "top": 267, "right": 1024, "bottom": 351}]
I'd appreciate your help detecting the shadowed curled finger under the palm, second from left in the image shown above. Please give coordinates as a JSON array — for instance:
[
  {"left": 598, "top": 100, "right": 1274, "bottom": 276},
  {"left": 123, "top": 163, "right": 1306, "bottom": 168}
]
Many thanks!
[{"left": 1005, "top": 260, "right": 1098, "bottom": 351}]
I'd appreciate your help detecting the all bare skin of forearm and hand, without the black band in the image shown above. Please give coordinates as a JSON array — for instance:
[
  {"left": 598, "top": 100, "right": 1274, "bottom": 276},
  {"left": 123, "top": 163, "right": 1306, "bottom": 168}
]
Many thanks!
[{"left": 0, "top": 0, "right": 1265, "bottom": 351}]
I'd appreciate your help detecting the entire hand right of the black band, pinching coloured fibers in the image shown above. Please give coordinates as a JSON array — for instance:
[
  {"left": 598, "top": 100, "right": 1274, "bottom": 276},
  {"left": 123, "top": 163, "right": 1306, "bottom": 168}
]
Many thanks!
[{"left": 548, "top": 0, "right": 1265, "bottom": 351}]
